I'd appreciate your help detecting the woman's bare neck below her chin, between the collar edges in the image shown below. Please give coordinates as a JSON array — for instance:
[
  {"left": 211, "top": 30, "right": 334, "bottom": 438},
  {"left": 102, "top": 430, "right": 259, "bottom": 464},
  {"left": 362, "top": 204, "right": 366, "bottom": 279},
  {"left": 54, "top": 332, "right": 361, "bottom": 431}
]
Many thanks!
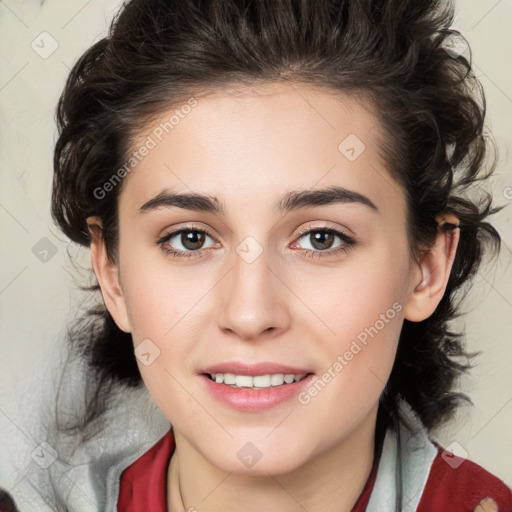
[{"left": 167, "top": 409, "right": 377, "bottom": 512}]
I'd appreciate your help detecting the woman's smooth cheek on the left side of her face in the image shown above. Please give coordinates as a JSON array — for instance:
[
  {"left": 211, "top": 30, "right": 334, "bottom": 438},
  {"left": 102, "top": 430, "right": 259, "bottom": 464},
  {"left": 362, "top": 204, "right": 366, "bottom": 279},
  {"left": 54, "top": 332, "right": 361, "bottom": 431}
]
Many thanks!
[{"left": 121, "top": 251, "right": 215, "bottom": 414}]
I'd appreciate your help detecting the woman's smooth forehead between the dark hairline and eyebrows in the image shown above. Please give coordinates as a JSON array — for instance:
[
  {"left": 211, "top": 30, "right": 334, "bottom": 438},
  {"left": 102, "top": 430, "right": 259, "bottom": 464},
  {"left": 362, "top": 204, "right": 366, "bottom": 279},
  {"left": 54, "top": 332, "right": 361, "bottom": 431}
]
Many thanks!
[{"left": 121, "top": 83, "right": 405, "bottom": 220}]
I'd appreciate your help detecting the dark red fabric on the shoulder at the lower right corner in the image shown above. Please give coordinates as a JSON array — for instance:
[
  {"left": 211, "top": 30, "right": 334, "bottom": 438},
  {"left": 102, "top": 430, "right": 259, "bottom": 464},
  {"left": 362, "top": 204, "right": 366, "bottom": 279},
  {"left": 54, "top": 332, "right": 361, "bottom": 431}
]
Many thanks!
[{"left": 417, "top": 446, "right": 512, "bottom": 512}]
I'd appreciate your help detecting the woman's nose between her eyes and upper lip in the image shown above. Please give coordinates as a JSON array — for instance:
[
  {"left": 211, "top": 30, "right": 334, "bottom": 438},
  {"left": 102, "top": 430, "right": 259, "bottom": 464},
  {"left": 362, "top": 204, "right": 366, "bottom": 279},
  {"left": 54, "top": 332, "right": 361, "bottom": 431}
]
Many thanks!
[{"left": 219, "top": 242, "right": 292, "bottom": 341}]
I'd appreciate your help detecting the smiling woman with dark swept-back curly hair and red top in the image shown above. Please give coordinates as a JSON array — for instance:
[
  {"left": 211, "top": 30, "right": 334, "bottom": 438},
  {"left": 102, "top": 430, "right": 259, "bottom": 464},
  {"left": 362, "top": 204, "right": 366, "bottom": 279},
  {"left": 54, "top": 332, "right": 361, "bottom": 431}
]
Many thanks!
[{"left": 8, "top": 0, "right": 512, "bottom": 512}]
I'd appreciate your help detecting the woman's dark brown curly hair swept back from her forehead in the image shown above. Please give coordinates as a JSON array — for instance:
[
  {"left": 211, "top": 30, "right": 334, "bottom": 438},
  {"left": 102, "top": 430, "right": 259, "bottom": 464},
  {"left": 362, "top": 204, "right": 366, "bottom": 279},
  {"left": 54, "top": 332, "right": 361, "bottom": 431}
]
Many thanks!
[{"left": 52, "top": 0, "right": 501, "bottom": 436}]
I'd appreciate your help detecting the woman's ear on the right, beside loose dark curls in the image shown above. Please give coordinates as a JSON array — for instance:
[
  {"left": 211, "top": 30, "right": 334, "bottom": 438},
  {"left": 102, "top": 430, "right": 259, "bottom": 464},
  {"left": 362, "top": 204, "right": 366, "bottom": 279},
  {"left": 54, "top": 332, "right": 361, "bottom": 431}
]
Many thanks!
[{"left": 404, "top": 214, "right": 460, "bottom": 322}]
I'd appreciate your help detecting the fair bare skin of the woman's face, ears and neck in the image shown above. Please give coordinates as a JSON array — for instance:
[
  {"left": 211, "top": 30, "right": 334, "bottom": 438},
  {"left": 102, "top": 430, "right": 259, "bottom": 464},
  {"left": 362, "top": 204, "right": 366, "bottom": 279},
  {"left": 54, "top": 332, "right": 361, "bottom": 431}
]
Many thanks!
[{"left": 89, "top": 84, "right": 459, "bottom": 512}]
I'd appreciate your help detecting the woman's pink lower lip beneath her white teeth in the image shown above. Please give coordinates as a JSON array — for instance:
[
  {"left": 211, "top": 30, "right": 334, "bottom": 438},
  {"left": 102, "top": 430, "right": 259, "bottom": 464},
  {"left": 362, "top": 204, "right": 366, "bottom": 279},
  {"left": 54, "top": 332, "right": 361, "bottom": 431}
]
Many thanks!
[{"left": 200, "top": 373, "right": 314, "bottom": 412}]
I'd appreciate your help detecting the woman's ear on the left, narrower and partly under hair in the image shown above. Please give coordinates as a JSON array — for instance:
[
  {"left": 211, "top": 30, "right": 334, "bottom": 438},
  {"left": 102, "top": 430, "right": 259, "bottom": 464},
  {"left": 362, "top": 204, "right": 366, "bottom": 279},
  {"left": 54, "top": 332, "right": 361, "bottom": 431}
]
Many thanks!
[{"left": 87, "top": 217, "right": 131, "bottom": 332}]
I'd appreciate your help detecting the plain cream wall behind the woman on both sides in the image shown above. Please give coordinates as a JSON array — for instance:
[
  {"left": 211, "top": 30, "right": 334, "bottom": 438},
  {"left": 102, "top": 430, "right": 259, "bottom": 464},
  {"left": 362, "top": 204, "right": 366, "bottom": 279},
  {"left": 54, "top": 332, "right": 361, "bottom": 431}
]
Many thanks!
[{"left": 0, "top": 0, "right": 512, "bottom": 506}]
